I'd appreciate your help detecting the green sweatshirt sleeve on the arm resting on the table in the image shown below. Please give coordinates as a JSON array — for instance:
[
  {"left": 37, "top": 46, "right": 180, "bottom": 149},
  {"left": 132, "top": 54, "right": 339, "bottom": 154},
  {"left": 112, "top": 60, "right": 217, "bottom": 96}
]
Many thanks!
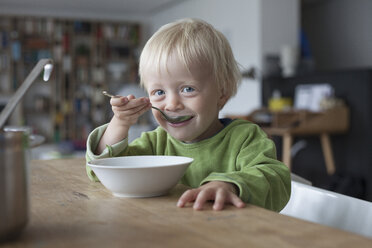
[{"left": 202, "top": 125, "right": 291, "bottom": 212}]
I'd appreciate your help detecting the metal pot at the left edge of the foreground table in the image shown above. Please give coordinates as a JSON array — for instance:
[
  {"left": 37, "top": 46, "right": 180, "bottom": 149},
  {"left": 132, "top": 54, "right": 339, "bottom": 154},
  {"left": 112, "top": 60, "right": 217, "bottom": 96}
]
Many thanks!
[{"left": 0, "top": 127, "right": 42, "bottom": 241}]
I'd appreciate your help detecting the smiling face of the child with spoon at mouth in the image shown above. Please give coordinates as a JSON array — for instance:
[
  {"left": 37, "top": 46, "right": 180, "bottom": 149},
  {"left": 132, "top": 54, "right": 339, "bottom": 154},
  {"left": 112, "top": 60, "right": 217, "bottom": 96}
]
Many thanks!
[{"left": 143, "top": 56, "right": 225, "bottom": 143}]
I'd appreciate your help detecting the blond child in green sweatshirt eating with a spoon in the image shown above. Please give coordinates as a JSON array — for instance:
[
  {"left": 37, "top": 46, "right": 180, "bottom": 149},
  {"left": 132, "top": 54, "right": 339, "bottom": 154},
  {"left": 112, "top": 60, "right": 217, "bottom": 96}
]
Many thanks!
[{"left": 87, "top": 19, "right": 291, "bottom": 211}]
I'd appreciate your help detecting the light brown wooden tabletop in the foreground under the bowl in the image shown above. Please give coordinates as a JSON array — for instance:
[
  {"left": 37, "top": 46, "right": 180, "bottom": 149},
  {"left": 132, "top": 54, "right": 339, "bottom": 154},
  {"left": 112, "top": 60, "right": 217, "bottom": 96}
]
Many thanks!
[{"left": 0, "top": 159, "right": 372, "bottom": 248}]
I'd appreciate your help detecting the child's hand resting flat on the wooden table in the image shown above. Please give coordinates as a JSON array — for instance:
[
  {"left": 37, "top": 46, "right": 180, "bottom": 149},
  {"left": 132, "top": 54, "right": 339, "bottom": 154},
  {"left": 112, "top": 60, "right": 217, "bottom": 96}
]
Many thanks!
[{"left": 177, "top": 181, "right": 245, "bottom": 210}]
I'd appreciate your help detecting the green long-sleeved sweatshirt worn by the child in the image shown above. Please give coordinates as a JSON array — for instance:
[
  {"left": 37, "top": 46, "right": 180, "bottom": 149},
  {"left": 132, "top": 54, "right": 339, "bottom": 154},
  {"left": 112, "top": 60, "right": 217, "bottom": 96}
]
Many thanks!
[{"left": 86, "top": 120, "right": 291, "bottom": 211}]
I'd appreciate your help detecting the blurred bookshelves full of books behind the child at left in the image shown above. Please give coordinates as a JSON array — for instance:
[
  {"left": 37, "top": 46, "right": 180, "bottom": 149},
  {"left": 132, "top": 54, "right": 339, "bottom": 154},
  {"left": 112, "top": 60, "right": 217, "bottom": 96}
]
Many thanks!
[{"left": 0, "top": 16, "right": 141, "bottom": 146}]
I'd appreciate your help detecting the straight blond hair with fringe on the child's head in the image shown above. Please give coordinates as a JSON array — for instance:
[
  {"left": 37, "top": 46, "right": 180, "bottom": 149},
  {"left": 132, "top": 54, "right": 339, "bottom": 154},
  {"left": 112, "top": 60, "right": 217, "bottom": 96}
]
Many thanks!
[{"left": 139, "top": 18, "right": 241, "bottom": 99}]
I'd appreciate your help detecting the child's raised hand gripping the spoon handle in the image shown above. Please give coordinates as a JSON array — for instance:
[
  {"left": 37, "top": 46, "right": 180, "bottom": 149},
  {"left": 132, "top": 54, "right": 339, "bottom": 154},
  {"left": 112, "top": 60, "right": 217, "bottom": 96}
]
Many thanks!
[{"left": 110, "top": 95, "right": 151, "bottom": 127}]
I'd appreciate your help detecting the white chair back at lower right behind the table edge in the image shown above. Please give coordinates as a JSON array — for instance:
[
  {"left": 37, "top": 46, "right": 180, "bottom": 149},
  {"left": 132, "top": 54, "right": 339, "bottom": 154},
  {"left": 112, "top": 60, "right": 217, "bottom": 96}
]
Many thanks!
[{"left": 280, "top": 181, "right": 372, "bottom": 238}]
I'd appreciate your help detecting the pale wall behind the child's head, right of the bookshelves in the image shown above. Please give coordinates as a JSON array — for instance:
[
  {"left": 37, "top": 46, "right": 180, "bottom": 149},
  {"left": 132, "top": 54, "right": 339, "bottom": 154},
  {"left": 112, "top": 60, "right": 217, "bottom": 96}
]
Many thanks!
[{"left": 149, "top": 0, "right": 299, "bottom": 116}]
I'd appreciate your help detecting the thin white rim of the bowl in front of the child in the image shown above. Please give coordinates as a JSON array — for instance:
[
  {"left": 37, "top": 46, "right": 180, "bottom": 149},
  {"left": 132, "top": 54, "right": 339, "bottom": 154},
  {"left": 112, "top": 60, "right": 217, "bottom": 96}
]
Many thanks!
[{"left": 87, "top": 155, "right": 194, "bottom": 169}]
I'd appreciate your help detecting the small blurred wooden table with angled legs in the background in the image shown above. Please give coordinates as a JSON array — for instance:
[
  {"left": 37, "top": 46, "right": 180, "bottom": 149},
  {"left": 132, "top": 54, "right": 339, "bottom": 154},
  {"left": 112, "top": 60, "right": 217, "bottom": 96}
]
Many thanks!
[{"left": 229, "top": 106, "right": 350, "bottom": 175}]
